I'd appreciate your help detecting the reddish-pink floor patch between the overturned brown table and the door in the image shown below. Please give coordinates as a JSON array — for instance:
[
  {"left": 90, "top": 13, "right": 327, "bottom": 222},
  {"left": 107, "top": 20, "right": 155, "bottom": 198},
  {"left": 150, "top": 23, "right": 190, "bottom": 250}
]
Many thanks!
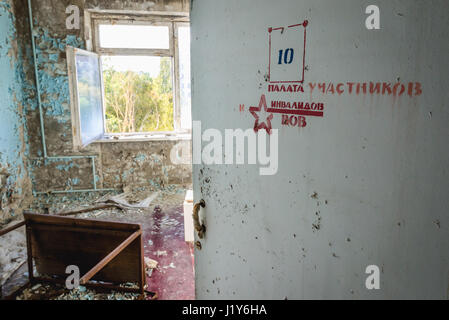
[{"left": 143, "top": 206, "right": 195, "bottom": 300}]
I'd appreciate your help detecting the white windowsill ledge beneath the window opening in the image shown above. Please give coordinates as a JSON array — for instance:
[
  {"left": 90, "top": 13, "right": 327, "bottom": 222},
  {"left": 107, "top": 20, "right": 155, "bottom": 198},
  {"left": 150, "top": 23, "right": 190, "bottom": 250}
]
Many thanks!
[{"left": 95, "top": 132, "right": 192, "bottom": 143}]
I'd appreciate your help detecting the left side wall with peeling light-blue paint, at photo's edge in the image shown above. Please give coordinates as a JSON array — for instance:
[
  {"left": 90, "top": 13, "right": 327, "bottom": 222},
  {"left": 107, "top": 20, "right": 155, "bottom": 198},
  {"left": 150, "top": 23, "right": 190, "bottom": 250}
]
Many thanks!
[{"left": 0, "top": 0, "right": 33, "bottom": 224}]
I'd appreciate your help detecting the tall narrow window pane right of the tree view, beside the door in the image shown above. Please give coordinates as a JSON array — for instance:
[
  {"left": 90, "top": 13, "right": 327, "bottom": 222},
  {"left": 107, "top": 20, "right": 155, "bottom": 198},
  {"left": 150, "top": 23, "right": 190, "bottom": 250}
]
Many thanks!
[{"left": 178, "top": 27, "right": 192, "bottom": 129}]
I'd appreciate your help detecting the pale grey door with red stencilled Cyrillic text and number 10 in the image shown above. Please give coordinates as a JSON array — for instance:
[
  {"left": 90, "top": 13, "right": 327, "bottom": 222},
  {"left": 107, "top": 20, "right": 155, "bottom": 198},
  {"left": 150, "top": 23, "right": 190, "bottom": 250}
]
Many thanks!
[{"left": 191, "top": 0, "right": 449, "bottom": 299}]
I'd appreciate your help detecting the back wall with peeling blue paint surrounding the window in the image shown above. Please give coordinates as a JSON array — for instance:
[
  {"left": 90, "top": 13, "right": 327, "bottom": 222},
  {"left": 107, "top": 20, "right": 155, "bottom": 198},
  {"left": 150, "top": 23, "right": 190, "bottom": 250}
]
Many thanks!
[{"left": 20, "top": 0, "right": 191, "bottom": 192}]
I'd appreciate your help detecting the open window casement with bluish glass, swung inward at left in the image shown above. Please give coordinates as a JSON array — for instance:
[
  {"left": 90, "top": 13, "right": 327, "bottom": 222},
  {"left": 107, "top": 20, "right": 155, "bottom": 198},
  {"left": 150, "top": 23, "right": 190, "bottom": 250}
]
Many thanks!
[{"left": 67, "top": 46, "right": 105, "bottom": 150}]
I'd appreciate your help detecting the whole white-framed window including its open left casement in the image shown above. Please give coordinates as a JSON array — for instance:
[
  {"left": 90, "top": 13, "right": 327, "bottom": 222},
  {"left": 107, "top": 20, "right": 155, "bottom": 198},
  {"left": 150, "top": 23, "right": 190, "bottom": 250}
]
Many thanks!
[{"left": 67, "top": 15, "right": 192, "bottom": 149}]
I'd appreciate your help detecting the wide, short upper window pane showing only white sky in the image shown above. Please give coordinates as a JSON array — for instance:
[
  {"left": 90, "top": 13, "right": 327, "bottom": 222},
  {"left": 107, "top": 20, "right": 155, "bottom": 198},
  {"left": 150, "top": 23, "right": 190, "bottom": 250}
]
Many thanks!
[{"left": 99, "top": 24, "right": 170, "bottom": 49}]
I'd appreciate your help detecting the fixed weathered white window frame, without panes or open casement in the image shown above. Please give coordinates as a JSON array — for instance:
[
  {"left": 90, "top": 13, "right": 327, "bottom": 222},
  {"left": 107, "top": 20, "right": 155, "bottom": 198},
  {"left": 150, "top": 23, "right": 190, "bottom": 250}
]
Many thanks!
[{"left": 80, "top": 12, "right": 192, "bottom": 143}]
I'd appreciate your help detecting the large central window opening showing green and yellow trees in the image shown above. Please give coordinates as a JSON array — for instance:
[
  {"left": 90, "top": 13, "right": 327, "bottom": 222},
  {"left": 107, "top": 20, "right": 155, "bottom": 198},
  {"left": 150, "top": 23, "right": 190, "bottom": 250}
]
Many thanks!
[{"left": 101, "top": 56, "right": 174, "bottom": 133}]
